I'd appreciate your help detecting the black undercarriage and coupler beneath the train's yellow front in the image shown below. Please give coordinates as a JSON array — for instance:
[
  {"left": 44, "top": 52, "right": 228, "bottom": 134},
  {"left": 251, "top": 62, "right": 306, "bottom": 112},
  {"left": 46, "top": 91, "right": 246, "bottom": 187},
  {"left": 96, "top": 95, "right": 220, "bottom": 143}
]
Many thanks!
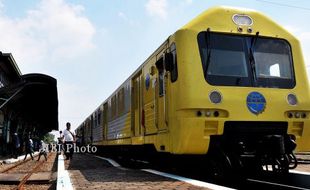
[{"left": 207, "top": 122, "right": 297, "bottom": 177}]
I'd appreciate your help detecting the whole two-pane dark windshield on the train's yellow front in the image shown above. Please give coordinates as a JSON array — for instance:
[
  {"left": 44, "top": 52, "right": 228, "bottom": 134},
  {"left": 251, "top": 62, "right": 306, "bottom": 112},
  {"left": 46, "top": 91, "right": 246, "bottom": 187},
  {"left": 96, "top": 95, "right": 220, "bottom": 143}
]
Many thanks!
[{"left": 198, "top": 32, "right": 295, "bottom": 88}]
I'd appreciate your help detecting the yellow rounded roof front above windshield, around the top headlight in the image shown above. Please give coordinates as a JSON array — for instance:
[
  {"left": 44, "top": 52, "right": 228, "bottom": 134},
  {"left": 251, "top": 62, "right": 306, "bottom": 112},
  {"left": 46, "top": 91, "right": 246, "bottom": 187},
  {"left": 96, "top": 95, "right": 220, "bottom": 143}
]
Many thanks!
[{"left": 180, "top": 6, "right": 297, "bottom": 40}]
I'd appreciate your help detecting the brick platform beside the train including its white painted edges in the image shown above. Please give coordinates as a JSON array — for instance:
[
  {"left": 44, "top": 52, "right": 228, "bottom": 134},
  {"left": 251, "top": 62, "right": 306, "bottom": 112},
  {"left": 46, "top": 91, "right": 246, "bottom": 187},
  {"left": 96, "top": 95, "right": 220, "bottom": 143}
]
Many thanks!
[{"left": 57, "top": 154, "right": 234, "bottom": 190}]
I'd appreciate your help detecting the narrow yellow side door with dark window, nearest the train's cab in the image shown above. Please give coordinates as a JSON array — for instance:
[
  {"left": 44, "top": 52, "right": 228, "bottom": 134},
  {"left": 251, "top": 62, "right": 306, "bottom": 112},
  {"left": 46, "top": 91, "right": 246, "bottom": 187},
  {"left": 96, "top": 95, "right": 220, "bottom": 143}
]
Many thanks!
[{"left": 155, "top": 56, "right": 169, "bottom": 132}]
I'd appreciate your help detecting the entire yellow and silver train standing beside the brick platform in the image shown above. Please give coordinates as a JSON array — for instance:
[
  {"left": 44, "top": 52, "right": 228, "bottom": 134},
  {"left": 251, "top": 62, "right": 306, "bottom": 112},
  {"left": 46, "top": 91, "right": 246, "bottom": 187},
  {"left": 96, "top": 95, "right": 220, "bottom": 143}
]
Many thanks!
[{"left": 76, "top": 7, "right": 310, "bottom": 175}]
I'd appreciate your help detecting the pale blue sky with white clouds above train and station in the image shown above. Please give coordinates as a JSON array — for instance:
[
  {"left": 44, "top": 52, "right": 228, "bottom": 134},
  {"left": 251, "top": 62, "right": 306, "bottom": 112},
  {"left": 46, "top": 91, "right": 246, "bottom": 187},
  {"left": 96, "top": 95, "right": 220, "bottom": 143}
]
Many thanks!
[{"left": 0, "top": 0, "right": 310, "bottom": 132}]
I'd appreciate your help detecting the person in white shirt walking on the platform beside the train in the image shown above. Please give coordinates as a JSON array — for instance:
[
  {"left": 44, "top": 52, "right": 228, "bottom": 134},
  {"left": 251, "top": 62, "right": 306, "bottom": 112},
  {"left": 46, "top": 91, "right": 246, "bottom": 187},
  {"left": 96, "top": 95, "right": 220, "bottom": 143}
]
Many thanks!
[{"left": 63, "top": 122, "right": 76, "bottom": 160}]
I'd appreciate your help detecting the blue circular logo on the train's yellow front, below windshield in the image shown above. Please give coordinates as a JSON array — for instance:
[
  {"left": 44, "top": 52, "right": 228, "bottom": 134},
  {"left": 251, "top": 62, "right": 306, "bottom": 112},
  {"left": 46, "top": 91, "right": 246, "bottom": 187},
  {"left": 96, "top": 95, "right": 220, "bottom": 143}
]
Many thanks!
[{"left": 246, "top": 92, "right": 266, "bottom": 115}]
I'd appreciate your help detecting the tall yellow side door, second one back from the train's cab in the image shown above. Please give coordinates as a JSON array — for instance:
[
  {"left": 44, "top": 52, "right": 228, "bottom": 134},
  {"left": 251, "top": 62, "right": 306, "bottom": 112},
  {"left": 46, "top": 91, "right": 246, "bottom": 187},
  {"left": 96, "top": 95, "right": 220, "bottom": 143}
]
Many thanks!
[{"left": 131, "top": 72, "right": 142, "bottom": 136}]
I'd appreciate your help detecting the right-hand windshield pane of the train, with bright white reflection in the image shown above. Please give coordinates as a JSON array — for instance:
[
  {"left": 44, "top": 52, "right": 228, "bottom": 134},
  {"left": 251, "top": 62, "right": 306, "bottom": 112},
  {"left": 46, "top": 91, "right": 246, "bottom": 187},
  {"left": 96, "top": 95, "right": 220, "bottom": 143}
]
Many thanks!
[{"left": 253, "top": 38, "right": 295, "bottom": 88}]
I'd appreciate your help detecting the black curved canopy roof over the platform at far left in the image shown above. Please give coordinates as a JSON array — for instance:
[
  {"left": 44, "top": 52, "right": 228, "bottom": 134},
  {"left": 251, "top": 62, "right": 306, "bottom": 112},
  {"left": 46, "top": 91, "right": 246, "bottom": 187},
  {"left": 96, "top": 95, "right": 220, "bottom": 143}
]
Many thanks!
[{"left": 0, "top": 54, "right": 58, "bottom": 134}]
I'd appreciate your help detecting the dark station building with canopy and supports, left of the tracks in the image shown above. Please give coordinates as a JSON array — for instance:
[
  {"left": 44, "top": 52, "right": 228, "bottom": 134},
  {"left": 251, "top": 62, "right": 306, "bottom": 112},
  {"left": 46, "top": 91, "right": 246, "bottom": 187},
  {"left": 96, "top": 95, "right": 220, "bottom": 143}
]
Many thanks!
[{"left": 0, "top": 52, "right": 58, "bottom": 156}]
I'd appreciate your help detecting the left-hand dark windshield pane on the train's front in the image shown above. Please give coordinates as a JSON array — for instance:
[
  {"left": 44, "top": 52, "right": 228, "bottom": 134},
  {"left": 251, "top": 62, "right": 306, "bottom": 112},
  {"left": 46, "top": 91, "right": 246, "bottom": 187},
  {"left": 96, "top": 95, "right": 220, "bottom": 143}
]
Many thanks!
[{"left": 198, "top": 32, "right": 251, "bottom": 86}]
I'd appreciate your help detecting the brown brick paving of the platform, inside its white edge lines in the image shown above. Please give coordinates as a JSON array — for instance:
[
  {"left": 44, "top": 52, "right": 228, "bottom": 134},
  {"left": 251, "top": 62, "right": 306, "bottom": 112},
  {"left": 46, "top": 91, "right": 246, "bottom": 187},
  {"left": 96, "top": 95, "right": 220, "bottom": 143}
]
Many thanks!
[{"left": 65, "top": 154, "right": 212, "bottom": 190}]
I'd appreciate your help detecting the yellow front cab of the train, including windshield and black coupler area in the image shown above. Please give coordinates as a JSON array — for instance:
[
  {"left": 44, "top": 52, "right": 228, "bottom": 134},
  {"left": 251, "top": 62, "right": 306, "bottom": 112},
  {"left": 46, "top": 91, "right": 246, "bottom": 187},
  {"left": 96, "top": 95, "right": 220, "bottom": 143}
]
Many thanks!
[{"left": 173, "top": 7, "right": 310, "bottom": 173}]
